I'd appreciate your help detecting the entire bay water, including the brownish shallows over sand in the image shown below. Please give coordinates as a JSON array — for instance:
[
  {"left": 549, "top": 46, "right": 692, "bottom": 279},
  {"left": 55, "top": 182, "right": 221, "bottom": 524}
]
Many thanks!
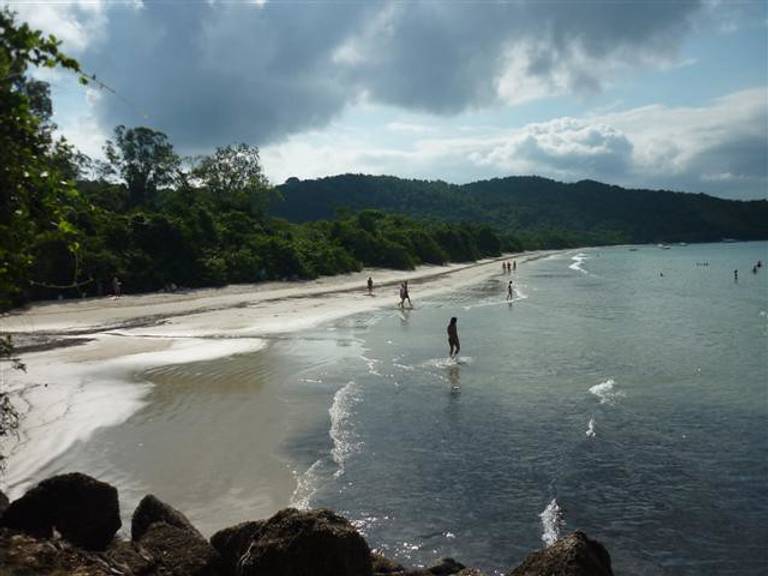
[{"left": 18, "top": 243, "right": 768, "bottom": 575}]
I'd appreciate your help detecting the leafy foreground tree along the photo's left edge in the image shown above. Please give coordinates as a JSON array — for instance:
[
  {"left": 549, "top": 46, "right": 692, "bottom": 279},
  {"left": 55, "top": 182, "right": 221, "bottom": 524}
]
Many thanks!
[{"left": 0, "top": 8, "right": 87, "bottom": 310}]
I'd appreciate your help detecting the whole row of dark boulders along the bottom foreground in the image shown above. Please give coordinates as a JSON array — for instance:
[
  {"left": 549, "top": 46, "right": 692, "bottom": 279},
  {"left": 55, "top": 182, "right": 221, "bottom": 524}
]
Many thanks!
[{"left": 0, "top": 474, "right": 613, "bottom": 576}]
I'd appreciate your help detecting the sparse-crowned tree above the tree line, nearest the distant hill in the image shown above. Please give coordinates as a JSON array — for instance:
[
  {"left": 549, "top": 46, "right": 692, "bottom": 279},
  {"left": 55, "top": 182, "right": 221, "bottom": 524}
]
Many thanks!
[{"left": 192, "top": 144, "right": 275, "bottom": 218}]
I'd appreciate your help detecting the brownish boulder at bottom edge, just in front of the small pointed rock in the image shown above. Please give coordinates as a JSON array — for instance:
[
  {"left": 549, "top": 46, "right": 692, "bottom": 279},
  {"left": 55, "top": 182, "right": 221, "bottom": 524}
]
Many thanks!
[{"left": 138, "top": 522, "right": 224, "bottom": 576}]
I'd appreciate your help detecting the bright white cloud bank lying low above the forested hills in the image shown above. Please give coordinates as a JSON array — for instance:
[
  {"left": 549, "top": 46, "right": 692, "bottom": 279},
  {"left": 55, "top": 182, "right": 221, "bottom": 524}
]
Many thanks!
[{"left": 262, "top": 88, "right": 768, "bottom": 198}]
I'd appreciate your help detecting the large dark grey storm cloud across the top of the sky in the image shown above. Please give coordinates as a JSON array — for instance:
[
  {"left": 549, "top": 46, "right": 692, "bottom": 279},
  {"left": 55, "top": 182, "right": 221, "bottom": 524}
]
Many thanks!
[{"left": 81, "top": 2, "right": 698, "bottom": 149}]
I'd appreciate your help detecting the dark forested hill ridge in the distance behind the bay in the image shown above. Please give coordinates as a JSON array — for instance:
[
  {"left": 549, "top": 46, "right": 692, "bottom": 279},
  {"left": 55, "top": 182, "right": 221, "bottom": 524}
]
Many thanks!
[{"left": 272, "top": 174, "right": 768, "bottom": 245}]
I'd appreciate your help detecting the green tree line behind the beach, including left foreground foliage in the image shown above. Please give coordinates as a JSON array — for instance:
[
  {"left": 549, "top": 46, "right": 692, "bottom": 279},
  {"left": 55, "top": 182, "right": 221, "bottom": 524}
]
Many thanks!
[{"left": 0, "top": 9, "right": 506, "bottom": 310}]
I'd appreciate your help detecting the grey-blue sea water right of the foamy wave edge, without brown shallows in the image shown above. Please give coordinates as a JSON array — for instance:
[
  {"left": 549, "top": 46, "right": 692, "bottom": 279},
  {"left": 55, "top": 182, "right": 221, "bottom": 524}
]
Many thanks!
[{"left": 286, "top": 243, "right": 768, "bottom": 576}]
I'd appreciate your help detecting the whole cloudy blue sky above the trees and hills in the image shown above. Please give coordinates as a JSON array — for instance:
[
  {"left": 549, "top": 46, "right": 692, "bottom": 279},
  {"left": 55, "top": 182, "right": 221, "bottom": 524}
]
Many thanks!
[{"left": 7, "top": 0, "right": 768, "bottom": 199}]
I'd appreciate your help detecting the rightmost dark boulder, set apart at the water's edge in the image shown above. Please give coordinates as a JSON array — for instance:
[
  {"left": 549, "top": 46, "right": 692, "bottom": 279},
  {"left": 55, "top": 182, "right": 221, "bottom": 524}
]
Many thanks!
[{"left": 507, "top": 532, "right": 613, "bottom": 576}]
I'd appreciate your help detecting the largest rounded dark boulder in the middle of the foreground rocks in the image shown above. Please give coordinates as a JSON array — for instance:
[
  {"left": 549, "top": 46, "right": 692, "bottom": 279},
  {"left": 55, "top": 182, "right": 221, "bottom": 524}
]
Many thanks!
[{"left": 237, "top": 508, "right": 372, "bottom": 576}]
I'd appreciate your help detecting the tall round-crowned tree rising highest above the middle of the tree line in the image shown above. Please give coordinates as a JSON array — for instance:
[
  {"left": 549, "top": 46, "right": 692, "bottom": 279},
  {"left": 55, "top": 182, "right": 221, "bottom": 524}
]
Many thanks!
[{"left": 102, "top": 125, "right": 181, "bottom": 208}]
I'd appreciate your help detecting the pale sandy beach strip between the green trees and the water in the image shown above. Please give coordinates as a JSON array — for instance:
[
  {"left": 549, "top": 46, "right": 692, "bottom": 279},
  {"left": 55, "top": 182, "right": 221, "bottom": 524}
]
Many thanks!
[{"left": 0, "top": 253, "right": 546, "bottom": 511}]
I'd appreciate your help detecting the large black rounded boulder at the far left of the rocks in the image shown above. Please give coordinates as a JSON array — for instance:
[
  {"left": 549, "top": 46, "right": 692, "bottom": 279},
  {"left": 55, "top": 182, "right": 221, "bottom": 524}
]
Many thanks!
[{"left": 2, "top": 473, "right": 122, "bottom": 550}]
